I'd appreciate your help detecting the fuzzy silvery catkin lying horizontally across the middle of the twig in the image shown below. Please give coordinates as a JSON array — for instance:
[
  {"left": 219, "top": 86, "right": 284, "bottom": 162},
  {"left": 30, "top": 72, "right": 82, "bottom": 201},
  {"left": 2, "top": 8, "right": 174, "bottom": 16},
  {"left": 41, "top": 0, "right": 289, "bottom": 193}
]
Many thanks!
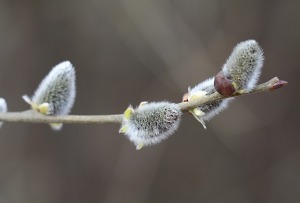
[{"left": 120, "top": 102, "right": 181, "bottom": 149}]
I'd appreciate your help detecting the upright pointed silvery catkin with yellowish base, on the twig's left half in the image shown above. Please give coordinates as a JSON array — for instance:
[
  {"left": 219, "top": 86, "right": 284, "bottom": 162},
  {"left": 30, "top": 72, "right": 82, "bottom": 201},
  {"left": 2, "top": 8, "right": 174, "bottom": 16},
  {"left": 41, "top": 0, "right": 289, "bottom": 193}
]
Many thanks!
[{"left": 23, "top": 61, "right": 76, "bottom": 130}]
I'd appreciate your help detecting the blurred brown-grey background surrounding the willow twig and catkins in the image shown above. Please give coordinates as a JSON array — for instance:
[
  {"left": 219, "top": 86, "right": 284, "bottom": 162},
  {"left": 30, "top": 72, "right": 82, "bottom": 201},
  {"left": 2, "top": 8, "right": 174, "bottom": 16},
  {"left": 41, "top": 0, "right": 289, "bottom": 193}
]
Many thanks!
[{"left": 0, "top": 0, "right": 300, "bottom": 203}]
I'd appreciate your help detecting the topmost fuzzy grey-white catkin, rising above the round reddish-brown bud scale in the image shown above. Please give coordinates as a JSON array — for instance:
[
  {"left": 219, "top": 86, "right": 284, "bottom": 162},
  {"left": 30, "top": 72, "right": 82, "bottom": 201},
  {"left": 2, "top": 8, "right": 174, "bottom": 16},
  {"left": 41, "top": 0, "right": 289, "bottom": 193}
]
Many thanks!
[{"left": 222, "top": 40, "right": 264, "bottom": 90}]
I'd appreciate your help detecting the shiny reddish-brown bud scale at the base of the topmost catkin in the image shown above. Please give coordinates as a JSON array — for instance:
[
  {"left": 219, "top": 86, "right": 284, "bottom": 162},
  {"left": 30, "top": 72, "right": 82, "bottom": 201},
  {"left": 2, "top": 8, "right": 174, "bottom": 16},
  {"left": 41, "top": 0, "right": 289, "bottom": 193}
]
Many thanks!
[{"left": 214, "top": 71, "right": 236, "bottom": 96}]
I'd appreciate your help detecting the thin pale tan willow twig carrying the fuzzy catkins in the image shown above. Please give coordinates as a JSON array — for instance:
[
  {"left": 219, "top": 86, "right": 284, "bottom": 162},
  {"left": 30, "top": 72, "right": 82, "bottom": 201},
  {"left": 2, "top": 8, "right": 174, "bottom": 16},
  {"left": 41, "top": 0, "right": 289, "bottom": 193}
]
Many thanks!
[{"left": 0, "top": 77, "right": 287, "bottom": 124}]
